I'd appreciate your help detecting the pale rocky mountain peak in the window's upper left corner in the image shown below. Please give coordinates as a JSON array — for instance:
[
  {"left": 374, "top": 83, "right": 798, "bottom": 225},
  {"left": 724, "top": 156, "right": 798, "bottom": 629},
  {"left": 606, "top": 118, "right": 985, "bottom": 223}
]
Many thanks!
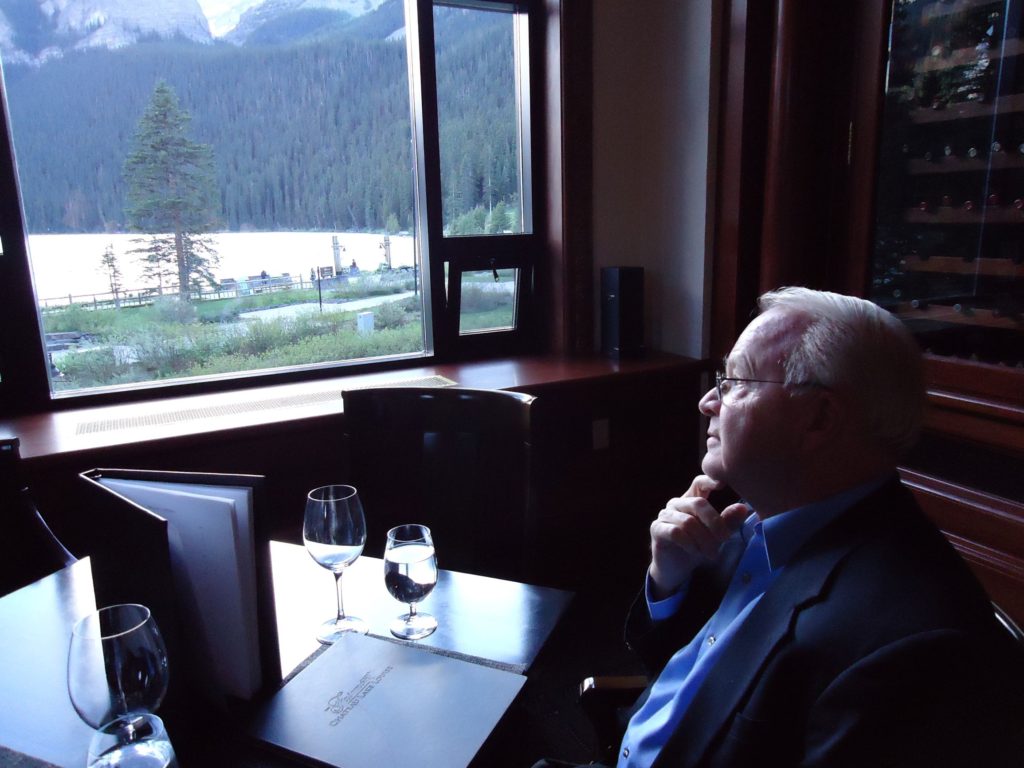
[{"left": 0, "top": 0, "right": 213, "bottom": 65}]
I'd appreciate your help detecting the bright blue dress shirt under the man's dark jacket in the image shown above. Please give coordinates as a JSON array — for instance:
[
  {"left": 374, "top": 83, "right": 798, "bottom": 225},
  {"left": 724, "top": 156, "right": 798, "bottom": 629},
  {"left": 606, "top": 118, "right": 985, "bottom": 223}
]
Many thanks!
[{"left": 617, "top": 478, "right": 885, "bottom": 768}]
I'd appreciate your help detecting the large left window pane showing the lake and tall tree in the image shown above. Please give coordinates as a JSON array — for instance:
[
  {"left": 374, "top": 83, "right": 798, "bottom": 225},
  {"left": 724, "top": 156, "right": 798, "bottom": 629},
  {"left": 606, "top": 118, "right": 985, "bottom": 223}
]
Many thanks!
[{"left": 0, "top": 0, "right": 423, "bottom": 392}]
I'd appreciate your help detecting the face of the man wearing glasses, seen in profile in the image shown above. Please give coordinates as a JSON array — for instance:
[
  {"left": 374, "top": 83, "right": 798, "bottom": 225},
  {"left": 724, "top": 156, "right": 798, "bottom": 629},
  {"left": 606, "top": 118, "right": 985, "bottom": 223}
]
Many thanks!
[{"left": 699, "top": 309, "right": 806, "bottom": 512}]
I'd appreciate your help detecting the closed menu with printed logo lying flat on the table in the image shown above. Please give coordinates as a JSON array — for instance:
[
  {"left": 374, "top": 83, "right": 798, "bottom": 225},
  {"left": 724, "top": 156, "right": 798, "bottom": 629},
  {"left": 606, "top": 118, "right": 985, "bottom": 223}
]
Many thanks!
[{"left": 250, "top": 635, "right": 526, "bottom": 768}]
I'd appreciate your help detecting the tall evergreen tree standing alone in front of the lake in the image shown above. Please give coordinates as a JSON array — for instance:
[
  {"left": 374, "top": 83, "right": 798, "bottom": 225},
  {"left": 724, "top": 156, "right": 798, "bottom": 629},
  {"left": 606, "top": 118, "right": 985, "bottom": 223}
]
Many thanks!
[{"left": 124, "top": 81, "right": 220, "bottom": 301}]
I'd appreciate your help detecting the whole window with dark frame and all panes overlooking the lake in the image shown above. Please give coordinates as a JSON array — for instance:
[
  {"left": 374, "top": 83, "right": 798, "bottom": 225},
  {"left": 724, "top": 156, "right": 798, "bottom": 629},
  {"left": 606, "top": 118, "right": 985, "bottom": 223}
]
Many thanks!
[{"left": 0, "top": 0, "right": 538, "bottom": 415}]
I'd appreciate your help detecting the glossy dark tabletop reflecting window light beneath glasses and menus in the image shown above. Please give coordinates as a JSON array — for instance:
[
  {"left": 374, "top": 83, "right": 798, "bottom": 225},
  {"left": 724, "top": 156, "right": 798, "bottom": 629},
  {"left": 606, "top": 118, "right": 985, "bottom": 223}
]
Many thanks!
[{"left": 0, "top": 541, "right": 573, "bottom": 768}]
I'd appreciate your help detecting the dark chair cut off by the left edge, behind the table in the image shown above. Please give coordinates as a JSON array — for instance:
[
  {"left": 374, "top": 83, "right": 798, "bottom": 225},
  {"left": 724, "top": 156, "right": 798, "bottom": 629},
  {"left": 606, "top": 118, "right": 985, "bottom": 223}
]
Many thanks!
[{"left": 0, "top": 437, "right": 75, "bottom": 594}]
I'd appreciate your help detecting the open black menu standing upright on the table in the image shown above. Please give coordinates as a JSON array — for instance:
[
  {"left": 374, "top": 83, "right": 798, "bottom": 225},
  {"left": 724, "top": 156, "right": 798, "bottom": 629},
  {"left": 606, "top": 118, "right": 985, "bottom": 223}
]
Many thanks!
[{"left": 80, "top": 468, "right": 281, "bottom": 754}]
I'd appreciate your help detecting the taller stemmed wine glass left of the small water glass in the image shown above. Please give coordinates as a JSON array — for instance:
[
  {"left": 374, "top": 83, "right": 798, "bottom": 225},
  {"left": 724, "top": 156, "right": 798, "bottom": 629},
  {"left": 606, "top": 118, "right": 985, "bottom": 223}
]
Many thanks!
[{"left": 302, "top": 485, "right": 369, "bottom": 645}]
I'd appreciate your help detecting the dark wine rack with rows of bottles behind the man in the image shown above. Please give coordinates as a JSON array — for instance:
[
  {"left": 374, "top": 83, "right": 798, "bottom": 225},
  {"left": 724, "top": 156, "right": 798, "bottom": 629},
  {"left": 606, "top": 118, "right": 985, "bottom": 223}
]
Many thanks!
[{"left": 871, "top": 0, "right": 1024, "bottom": 369}]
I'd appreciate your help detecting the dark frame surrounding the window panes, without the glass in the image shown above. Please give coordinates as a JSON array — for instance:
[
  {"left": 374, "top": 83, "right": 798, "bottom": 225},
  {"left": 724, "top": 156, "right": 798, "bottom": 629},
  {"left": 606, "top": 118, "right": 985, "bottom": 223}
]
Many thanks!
[{"left": 0, "top": 0, "right": 557, "bottom": 416}]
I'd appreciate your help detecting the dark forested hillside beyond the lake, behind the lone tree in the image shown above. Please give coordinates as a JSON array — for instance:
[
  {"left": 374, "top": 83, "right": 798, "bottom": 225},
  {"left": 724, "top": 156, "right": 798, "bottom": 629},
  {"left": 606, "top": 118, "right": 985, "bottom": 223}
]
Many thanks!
[{"left": 4, "top": 0, "right": 517, "bottom": 232}]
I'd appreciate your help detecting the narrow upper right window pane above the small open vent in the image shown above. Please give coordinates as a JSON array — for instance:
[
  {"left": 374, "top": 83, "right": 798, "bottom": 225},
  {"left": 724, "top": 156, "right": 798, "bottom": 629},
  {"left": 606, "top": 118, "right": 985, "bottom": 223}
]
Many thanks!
[{"left": 434, "top": 3, "right": 531, "bottom": 237}]
